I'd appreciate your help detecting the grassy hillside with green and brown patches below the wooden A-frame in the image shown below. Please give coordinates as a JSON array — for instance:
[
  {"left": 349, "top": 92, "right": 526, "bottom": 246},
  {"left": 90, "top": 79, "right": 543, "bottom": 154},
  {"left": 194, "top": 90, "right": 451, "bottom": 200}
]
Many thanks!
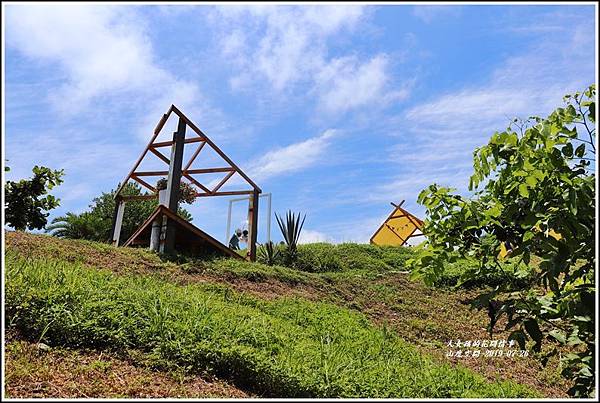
[{"left": 5, "top": 232, "right": 567, "bottom": 397}]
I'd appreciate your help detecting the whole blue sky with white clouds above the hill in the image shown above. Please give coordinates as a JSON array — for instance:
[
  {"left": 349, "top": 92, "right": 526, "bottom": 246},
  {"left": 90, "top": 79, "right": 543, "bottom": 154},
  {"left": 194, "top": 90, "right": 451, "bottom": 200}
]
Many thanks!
[{"left": 3, "top": 4, "right": 596, "bottom": 242}]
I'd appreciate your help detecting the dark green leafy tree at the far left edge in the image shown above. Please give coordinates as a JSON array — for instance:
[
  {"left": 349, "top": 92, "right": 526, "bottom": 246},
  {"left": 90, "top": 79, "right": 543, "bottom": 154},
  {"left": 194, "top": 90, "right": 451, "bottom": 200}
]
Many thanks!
[{"left": 5, "top": 165, "right": 64, "bottom": 231}]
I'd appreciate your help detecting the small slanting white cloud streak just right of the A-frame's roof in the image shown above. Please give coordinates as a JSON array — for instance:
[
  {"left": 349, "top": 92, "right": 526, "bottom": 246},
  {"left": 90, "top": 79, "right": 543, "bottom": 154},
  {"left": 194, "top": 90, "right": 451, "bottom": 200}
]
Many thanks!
[{"left": 248, "top": 129, "right": 336, "bottom": 181}]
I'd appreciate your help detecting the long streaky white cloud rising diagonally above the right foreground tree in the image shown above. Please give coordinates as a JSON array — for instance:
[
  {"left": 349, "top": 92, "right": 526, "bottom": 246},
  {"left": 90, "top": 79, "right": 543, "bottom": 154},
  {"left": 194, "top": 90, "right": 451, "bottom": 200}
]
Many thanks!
[{"left": 371, "top": 8, "right": 594, "bottom": 212}]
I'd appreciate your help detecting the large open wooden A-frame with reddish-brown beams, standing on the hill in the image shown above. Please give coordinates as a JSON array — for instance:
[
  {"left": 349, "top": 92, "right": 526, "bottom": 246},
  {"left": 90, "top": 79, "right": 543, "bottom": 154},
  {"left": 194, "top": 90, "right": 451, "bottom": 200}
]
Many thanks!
[{"left": 111, "top": 105, "right": 262, "bottom": 261}]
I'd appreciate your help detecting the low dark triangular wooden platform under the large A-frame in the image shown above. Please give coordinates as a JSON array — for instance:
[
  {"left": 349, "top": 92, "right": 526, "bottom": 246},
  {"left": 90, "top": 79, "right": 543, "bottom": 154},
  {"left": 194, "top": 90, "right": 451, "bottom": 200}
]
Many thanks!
[{"left": 123, "top": 204, "right": 244, "bottom": 260}]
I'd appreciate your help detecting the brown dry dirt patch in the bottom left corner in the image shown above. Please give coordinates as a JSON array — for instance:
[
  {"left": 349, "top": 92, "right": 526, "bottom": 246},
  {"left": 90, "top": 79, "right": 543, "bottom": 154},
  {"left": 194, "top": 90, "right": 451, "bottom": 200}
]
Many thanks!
[{"left": 5, "top": 339, "right": 249, "bottom": 398}]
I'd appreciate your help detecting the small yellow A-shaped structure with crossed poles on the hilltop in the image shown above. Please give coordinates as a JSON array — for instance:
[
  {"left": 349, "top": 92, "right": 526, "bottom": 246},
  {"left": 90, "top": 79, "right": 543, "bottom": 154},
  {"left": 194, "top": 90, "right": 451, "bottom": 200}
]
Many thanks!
[{"left": 370, "top": 200, "right": 423, "bottom": 246}]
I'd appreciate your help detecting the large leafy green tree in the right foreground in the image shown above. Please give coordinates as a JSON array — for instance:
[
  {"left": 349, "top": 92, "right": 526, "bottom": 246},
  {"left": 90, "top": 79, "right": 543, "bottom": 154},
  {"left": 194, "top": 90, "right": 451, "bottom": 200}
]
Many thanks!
[{"left": 411, "top": 86, "right": 596, "bottom": 396}]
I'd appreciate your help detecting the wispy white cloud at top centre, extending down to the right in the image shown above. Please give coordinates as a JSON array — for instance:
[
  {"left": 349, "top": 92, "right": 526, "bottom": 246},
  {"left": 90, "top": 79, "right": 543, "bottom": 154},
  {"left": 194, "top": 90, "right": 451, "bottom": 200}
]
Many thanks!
[{"left": 212, "top": 5, "right": 408, "bottom": 113}]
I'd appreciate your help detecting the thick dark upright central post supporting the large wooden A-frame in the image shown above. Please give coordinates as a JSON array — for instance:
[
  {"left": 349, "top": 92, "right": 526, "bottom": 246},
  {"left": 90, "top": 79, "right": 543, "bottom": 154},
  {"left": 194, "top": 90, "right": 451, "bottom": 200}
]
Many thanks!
[{"left": 159, "top": 118, "right": 186, "bottom": 253}]
